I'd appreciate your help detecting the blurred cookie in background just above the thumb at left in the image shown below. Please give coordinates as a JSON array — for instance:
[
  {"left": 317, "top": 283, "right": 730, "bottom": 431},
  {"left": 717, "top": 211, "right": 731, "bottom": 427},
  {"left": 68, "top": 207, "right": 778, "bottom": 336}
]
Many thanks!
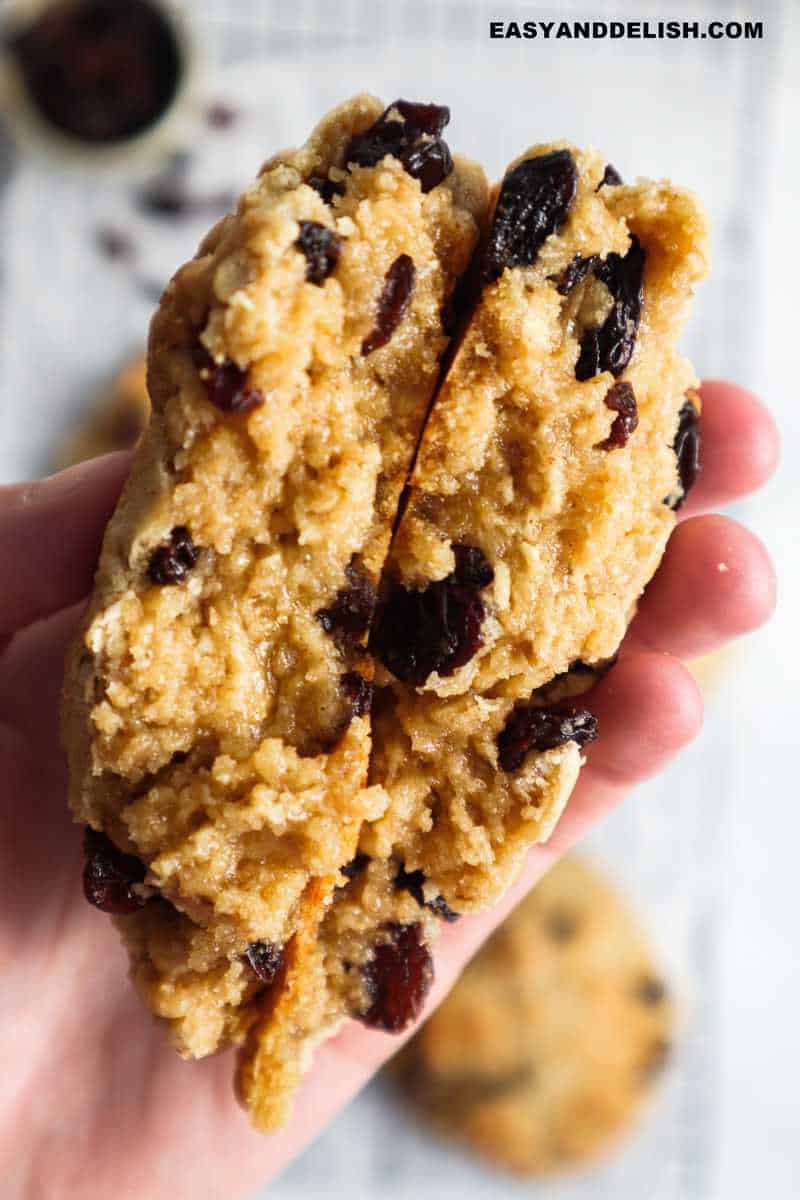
[{"left": 54, "top": 354, "right": 150, "bottom": 469}]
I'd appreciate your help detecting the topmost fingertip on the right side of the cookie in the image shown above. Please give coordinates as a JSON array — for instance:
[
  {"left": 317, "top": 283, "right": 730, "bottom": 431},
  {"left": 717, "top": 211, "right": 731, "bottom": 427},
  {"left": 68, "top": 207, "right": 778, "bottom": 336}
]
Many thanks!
[{"left": 679, "top": 379, "right": 780, "bottom": 520}]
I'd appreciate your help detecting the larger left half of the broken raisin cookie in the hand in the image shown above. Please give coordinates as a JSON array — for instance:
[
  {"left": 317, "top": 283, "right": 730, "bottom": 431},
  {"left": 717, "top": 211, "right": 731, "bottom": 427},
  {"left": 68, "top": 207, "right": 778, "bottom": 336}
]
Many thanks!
[{"left": 64, "top": 96, "right": 488, "bottom": 1086}]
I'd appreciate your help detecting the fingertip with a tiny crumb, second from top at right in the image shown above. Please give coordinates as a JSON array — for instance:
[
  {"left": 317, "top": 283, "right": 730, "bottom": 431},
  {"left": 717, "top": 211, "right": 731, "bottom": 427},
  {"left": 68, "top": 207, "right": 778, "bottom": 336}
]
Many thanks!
[{"left": 628, "top": 516, "right": 775, "bottom": 658}]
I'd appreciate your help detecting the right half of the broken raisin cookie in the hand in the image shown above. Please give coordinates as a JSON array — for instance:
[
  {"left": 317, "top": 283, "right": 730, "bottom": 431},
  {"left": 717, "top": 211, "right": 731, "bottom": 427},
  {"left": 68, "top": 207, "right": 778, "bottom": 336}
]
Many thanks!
[{"left": 361, "top": 143, "right": 708, "bottom": 912}]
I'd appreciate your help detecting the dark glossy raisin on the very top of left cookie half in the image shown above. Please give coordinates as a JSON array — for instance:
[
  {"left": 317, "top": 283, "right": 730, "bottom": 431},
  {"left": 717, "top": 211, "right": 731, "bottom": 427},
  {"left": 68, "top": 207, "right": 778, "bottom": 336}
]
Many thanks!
[{"left": 344, "top": 100, "right": 453, "bottom": 192}]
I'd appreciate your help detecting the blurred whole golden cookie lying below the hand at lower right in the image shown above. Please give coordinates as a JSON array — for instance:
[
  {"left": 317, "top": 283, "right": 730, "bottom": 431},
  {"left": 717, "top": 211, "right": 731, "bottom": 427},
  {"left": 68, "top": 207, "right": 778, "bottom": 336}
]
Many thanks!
[{"left": 397, "top": 858, "right": 673, "bottom": 1174}]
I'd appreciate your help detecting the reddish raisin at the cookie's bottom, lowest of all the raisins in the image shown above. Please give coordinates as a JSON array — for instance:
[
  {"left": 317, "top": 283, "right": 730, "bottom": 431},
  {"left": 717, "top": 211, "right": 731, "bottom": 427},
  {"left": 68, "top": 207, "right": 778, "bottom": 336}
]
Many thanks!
[{"left": 360, "top": 923, "right": 433, "bottom": 1033}]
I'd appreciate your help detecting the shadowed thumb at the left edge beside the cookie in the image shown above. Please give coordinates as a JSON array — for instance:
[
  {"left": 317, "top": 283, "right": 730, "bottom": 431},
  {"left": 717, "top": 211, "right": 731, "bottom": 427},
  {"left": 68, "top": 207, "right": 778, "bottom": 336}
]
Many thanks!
[{"left": 0, "top": 454, "right": 131, "bottom": 635}]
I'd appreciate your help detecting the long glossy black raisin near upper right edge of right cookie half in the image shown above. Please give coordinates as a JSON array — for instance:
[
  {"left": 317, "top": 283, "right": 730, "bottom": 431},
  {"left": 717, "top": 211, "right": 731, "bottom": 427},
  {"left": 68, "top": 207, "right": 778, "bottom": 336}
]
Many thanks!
[{"left": 575, "top": 236, "right": 644, "bottom": 383}]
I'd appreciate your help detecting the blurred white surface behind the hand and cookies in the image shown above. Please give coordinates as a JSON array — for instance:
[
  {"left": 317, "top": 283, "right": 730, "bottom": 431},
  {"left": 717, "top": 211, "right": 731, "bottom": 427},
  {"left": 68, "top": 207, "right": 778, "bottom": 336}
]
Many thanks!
[{"left": 0, "top": 0, "right": 800, "bottom": 1200}]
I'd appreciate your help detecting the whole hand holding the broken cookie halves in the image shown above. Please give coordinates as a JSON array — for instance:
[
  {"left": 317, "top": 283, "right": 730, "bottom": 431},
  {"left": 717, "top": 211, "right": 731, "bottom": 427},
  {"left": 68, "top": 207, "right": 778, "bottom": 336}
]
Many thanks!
[{"left": 0, "top": 384, "right": 776, "bottom": 1200}]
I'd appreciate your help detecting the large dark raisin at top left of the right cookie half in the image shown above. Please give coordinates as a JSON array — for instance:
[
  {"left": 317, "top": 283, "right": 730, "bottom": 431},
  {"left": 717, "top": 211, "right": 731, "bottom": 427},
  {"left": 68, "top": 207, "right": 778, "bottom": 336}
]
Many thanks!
[{"left": 481, "top": 150, "right": 578, "bottom": 283}]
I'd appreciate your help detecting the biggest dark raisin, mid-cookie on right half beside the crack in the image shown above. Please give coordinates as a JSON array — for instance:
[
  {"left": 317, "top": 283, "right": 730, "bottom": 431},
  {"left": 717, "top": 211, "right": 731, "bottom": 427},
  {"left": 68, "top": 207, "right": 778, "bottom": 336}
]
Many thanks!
[{"left": 371, "top": 546, "right": 494, "bottom": 686}]
